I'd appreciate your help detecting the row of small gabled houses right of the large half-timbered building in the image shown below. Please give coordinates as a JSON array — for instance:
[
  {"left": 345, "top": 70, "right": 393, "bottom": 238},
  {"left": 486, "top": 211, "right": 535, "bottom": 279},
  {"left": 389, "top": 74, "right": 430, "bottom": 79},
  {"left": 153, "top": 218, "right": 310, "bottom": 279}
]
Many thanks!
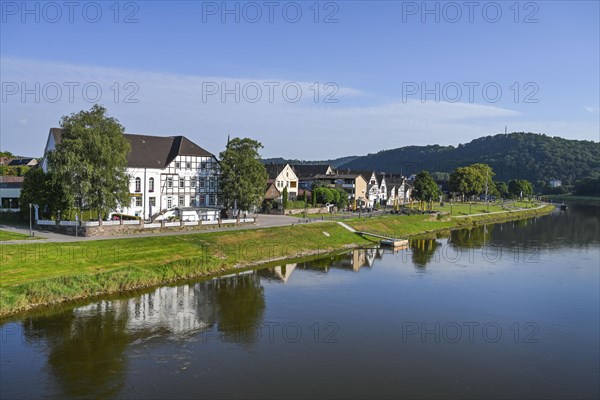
[{"left": 265, "top": 164, "right": 413, "bottom": 207}]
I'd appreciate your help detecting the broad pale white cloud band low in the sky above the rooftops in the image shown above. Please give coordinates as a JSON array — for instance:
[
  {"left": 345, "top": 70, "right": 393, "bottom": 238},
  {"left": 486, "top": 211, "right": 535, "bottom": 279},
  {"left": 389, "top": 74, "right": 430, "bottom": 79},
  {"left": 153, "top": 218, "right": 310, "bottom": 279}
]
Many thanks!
[{"left": 0, "top": 58, "right": 598, "bottom": 159}]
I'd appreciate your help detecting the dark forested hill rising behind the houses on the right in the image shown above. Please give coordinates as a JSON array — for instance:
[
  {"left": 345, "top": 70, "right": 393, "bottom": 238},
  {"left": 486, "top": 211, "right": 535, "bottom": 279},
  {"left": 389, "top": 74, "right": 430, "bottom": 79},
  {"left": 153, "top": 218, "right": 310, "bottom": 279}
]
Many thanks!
[{"left": 339, "top": 132, "right": 600, "bottom": 182}]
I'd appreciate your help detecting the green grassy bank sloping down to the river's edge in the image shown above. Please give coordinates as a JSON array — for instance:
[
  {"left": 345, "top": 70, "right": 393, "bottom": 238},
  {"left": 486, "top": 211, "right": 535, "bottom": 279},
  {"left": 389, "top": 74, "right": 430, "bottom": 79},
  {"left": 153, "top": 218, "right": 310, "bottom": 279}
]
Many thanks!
[{"left": 0, "top": 206, "right": 553, "bottom": 316}]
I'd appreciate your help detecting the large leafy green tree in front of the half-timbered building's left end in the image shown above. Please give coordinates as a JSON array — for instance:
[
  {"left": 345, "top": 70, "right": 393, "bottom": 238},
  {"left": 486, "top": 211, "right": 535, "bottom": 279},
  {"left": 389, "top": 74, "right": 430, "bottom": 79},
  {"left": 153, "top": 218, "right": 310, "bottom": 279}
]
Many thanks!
[{"left": 48, "top": 104, "right": 130, "bottom": 214}]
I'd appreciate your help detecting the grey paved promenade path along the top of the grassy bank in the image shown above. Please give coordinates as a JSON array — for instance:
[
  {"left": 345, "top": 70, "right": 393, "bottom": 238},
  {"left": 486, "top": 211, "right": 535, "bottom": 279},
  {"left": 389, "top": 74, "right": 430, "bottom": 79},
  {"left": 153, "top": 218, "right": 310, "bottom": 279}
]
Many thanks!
[{"left": 0, "top": 214, "right": 314, "bottom": 245}]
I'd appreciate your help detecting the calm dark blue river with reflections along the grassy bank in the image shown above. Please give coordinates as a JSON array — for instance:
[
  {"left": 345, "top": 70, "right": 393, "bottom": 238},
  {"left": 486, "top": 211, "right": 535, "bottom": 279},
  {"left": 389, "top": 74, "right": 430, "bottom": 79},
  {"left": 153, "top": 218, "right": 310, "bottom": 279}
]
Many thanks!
[{"left": 0, "top": 205, "right": 600, "bottom": 399}]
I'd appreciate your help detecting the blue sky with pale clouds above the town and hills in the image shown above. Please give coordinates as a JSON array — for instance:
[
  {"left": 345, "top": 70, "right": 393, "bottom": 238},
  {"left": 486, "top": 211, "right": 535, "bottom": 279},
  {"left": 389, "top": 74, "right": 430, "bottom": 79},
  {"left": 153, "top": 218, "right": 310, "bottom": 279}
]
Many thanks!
[{"left": 0, "top": 1, "right": 600, "bottom": 159}]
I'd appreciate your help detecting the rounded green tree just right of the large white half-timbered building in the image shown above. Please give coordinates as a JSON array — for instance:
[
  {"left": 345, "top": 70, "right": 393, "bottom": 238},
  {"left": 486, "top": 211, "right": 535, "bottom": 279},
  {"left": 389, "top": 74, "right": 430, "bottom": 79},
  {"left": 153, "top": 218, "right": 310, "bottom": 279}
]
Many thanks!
[{"left": 219, "top": 138, "right": 268, "bottom": 210}]
